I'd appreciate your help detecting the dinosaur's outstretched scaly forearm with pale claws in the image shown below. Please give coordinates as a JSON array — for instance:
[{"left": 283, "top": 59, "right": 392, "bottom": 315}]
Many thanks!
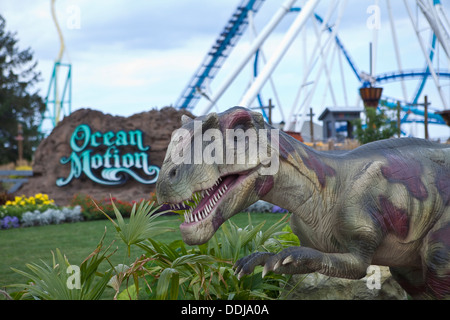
[{"left": 235, "top": 247, "right": 369, "bottom": 279}]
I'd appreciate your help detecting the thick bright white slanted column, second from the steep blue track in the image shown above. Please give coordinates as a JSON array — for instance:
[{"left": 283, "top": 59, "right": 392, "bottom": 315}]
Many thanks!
[{"left": 239, "top": 0, "right": 320, "bottom": 107}]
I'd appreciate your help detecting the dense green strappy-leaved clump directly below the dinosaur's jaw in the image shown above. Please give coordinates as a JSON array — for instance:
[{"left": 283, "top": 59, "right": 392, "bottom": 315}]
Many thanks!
[{"left": 130, "top": 212, "right": 287, "bottom": 299}]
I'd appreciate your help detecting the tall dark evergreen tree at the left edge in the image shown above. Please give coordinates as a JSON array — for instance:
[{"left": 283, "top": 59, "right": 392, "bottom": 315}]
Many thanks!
[{"left": 0, "top": 15, "right": 45, "bottom": 164}]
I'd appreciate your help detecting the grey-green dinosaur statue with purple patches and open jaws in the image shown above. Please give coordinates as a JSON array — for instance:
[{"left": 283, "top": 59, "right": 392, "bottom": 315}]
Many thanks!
[{"left": 156, "top": 107, "right": 450, "bottom": 299}]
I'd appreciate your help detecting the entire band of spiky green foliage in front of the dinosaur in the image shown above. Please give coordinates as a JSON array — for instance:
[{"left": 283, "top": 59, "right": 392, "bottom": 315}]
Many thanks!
[{"left": 7, "top": 202, "right": 300, "bottom": 300}]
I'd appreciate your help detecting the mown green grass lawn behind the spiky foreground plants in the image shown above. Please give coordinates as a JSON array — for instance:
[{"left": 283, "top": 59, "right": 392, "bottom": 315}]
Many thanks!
[{"left": 0, "top": 213, "right": 283, "bottom": 300}]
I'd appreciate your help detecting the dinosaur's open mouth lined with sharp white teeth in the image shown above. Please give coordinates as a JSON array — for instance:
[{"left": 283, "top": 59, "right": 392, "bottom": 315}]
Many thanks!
[{"left": 171, "top": 174, "right": 240, "bottom": 225}]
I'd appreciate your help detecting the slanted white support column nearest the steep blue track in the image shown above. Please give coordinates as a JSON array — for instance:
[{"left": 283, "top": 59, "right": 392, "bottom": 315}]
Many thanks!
[{"left": 200, "top": 0, "right": 295, "bottom": 114}]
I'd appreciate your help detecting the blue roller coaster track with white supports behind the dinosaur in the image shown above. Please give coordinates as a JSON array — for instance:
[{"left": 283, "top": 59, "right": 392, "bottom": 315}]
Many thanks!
[{"left": 175, "top": 0, "right": 450, "bottom": 138}]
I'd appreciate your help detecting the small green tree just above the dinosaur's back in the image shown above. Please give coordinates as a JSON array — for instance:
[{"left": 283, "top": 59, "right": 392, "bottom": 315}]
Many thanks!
[{"left": 354, "top": 108, "right": 397, "bottom": 144}]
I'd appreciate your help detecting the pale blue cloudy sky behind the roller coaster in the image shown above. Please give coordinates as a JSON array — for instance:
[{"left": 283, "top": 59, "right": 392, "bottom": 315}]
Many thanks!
[{"left": 0, "top": 0, "right": 450, "bottom": 139}]
